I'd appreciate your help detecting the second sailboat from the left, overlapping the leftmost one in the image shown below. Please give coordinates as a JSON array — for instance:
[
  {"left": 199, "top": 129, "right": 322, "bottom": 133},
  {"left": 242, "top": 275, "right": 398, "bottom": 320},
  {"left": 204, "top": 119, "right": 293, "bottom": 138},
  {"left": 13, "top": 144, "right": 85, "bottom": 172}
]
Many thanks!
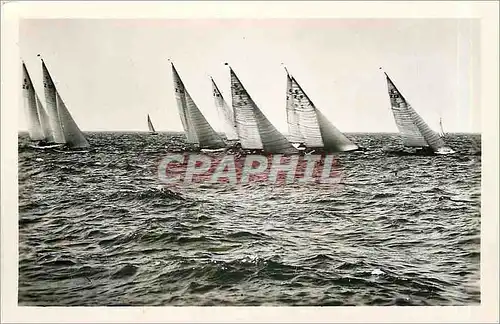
[{"left": 42, "top": 59, "right": 90, "bottom": 150}]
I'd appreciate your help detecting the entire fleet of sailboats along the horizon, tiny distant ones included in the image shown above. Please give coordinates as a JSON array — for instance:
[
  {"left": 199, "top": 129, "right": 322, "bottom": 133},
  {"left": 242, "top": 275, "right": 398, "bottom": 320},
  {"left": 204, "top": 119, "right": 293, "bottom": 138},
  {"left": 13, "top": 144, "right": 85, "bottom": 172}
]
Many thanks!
[{"left": 22, "top": 59, "right": 464, "bottom": 154}]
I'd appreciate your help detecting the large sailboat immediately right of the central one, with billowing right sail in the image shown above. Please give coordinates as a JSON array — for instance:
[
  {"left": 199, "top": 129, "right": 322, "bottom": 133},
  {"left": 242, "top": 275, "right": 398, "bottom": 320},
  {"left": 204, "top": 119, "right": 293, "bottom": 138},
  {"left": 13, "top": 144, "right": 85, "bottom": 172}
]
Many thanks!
[{"left": 285, "top": 68, "right": 359, "bottom": 152}]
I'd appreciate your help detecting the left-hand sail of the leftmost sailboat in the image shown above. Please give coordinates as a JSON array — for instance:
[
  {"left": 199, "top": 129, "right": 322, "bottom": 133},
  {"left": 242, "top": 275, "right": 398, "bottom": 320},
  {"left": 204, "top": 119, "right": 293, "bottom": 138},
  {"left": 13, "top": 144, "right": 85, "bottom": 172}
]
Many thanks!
[{"left": 22, "top": 62, "right": 46, "bottom": 141}]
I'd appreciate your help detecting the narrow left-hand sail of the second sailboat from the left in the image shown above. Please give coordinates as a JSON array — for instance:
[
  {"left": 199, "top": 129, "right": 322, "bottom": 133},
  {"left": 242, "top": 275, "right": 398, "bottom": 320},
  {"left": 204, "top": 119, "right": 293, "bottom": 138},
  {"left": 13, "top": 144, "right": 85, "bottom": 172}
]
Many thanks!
[{"left": 42, "top": 60, "right": 66, "bottom": 144}]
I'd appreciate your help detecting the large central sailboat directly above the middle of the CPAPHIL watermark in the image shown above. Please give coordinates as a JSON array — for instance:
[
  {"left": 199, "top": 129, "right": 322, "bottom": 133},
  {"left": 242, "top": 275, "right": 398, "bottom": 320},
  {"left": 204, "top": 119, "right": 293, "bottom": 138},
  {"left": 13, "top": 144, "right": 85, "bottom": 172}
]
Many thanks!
[{"left": 226, "top": 63, "right": 298, "bottom": 154}]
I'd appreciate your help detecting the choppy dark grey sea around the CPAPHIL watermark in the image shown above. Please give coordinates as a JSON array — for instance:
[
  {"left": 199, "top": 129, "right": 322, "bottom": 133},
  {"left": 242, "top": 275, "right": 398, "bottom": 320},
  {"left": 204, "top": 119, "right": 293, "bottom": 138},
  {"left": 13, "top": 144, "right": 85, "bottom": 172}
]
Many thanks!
[{"left": 18, "top": 133, "right": 481, "bottom": 306}]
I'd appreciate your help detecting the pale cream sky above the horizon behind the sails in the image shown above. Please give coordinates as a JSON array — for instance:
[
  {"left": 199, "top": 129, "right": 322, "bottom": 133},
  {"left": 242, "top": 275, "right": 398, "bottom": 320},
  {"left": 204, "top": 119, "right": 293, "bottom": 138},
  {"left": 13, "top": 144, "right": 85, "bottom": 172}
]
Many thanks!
[{"left": 18, "top": 19, "right": 481, "bottom": 133}]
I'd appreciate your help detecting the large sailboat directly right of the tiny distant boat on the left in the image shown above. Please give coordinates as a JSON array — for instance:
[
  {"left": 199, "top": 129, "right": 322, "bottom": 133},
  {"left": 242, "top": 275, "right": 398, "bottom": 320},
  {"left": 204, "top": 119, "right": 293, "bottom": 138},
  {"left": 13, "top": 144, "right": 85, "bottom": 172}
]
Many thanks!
[{"left": 171, "top": 63, "right": 226, "bottom": 151}]
